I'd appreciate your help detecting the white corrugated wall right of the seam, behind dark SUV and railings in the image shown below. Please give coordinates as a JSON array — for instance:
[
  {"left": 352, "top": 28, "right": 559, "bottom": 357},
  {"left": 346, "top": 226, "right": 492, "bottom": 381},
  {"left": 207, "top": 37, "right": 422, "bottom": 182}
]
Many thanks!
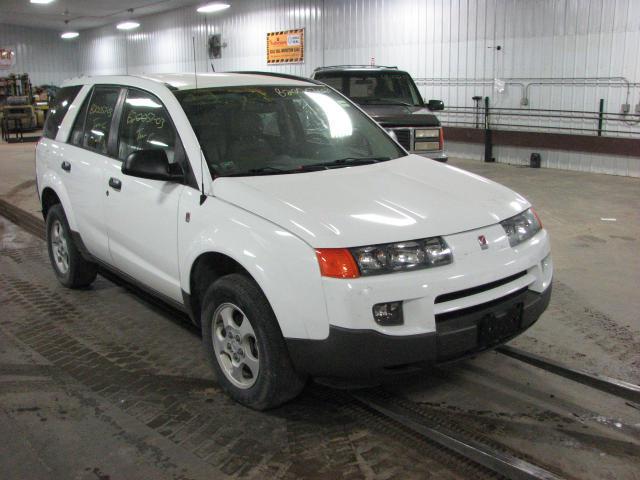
[{"left": 325, "top": 0, "right": 640, "bottom": 176}]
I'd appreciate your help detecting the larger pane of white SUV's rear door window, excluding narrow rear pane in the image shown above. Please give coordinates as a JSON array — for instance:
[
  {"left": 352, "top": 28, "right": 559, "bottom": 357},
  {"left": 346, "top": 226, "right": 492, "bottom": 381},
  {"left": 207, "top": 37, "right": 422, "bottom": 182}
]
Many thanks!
[{"left": 82, "top": 87, "right": 120, "bottom": 154}]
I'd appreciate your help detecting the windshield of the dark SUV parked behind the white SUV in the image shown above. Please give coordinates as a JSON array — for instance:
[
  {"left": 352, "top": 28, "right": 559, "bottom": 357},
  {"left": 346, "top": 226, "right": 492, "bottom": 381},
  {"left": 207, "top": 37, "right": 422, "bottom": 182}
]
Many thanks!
[{"left": 315, "top": 71, "right": 423, "bottom": 107}]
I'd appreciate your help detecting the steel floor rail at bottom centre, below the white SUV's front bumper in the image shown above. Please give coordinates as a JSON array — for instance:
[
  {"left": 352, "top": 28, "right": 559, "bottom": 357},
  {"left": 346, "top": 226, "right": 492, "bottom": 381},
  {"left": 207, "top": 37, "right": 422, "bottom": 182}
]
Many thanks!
[{"left": 351, "top": 393, "right": 562, "bottom": 480}]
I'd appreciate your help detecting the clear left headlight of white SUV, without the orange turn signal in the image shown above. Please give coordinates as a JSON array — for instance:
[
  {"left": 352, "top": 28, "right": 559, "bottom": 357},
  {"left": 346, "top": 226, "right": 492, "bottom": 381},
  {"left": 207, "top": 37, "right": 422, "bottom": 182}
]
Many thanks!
[{"left": 350, "top": 237, "right": 453, "bottom": 275}]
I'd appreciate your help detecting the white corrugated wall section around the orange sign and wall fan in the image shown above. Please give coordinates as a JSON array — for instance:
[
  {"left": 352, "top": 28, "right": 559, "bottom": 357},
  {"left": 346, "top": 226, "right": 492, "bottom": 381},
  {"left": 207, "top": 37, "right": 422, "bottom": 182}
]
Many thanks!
[{"left": 78, "top": 0, "right": 322, "bottom": 75}]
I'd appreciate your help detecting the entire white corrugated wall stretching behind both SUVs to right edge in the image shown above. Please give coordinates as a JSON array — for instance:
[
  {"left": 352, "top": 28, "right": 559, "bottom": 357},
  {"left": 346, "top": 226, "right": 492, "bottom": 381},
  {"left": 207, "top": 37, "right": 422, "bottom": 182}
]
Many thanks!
[{"left": 20, "top": 0, "right": 640, "bottom": 175}]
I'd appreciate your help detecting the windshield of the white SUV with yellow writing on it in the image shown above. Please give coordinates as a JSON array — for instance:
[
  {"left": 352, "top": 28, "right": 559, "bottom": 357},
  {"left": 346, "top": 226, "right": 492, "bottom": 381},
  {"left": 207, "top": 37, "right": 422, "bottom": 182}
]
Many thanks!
[{"left": 174, "top": 86, "right": 406, "bottom": 178}]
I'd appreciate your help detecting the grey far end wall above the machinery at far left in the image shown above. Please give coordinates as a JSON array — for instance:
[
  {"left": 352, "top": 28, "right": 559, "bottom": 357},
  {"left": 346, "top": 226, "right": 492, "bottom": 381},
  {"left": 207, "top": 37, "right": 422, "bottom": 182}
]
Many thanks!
[{"left": 0, "top": 24, "right": 78, "bottom": 85}]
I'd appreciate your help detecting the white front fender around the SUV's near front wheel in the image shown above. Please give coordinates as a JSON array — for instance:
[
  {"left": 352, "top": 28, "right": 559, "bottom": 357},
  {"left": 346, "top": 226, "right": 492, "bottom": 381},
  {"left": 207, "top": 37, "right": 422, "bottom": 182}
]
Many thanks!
[{"left": 178, "top": 206, "right": 329, "bottom": 339}]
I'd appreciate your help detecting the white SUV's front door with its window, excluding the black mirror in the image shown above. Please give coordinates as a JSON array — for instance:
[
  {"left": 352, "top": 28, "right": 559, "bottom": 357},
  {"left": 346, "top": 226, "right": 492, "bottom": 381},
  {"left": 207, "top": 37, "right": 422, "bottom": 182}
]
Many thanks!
[{"left": 104, "top": 88, "right": 187, "bottom": 302}]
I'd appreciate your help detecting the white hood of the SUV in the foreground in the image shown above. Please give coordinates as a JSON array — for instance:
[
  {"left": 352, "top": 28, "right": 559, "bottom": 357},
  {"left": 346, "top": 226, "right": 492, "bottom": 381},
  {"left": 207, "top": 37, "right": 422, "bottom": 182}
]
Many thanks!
[{"left": 212, "top": 155, "right": 530, "bottom": 248}]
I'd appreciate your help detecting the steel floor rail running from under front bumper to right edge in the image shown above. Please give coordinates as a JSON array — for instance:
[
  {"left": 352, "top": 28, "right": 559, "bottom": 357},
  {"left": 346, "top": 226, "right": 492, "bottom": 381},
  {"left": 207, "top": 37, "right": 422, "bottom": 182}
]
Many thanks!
[{"left": 495, "top": 345, "right": 640, "bottom": 403}]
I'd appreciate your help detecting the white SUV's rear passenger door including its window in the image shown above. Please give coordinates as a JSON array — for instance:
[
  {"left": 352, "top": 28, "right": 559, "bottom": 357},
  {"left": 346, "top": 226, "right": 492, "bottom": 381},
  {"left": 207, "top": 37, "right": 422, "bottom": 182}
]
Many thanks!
[{"left": 58, "top": 85, "right": 122, "bottom": 263}]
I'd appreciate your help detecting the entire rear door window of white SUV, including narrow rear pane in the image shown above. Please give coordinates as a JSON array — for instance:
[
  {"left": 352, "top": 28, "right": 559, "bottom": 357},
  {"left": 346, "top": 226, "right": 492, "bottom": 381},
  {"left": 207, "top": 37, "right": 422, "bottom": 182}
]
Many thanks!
[{"left": 71, "top": 87, "right": 120, "bottom": 154}]
